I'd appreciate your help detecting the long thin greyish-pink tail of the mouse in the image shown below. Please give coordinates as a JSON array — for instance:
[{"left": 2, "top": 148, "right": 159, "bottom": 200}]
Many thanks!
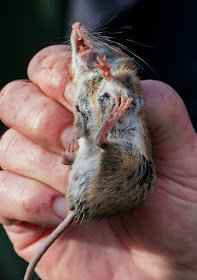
[{"left": 23, "top": 211, "right": 75, "bottom": 280}]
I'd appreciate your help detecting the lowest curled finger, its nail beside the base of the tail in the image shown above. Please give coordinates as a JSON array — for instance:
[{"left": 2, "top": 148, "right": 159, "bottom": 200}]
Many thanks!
[{"left": 0, "top": 171, "right": 68, "bottom": 226}]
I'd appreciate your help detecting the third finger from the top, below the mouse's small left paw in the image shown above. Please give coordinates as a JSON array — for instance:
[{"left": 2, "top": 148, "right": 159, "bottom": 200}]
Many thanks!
[{"left": 0, "top": 129, "right": 69, "bottom": 194}]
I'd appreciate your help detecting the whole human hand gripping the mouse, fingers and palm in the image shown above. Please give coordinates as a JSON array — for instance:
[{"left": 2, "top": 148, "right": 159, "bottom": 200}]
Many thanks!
[{"left": 0, "top": 46, "right": 197, "bottom": 280}]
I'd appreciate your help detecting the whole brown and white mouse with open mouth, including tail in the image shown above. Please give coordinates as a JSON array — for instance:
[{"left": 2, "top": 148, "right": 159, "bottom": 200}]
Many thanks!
[{"left": 24, "top": 22, "right": 156, "bottom": 280}]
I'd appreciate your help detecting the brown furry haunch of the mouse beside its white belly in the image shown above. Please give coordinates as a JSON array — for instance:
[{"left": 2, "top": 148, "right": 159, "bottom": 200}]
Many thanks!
[{"left": 76, "top": 144, "right": 155, "bottom": 222}]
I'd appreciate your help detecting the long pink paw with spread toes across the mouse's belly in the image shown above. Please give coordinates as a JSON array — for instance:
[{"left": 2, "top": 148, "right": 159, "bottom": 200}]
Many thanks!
[{"left": 96, "top": 95, "right": 133, "bottom": 147}]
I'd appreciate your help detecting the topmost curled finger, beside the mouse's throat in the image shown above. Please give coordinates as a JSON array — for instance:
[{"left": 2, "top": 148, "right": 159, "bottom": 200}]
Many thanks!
[{"left": 28, "top": 45, "right": 72, "bottom": 110}]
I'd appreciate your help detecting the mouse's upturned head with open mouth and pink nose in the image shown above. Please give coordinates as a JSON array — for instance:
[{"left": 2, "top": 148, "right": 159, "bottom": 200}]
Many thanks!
[{"left": 71, "top": 22, "right": 120, "bottom": 79}]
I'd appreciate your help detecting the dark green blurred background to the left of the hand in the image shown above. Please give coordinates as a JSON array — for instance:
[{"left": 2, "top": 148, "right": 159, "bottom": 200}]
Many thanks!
[{"left": 0, "top": 0, "right": 67, "bottom": 280}]
